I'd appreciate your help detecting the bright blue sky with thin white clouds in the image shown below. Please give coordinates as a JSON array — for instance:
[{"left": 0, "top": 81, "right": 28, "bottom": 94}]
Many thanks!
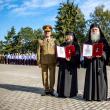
[{"left": 0, "top": 0, "right": 110, "bottom": 40}]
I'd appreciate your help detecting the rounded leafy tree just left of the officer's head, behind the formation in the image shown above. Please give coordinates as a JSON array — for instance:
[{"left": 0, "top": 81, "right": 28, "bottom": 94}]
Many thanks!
[{"left": 19, "top": 27, "right": 43, "bottom": 52}]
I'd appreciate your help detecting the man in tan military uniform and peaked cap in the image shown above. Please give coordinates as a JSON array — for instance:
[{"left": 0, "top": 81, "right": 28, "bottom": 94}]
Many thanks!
[{"left": 37, "top": 25, "right": 56, "bottom": 96}]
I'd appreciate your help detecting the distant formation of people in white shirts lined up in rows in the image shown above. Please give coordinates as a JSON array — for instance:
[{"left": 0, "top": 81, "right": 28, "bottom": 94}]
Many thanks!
[{"left": 0, "top": 53, "right": 37, "bottom": 65}]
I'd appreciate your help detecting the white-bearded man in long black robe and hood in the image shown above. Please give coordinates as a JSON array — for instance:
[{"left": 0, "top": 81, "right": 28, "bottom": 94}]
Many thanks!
[{"left": 83, "top": 23, "right": 109, "bottom": 101}]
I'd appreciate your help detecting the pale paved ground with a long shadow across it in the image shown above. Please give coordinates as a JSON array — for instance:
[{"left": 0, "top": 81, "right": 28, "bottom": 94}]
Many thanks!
[{"left": 0, "top": 64, "right": 110, "bottom": 110}]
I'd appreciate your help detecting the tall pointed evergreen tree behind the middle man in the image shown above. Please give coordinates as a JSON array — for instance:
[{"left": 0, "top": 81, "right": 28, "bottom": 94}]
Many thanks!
[{"left": 55, "top": 0, "right": 85, "bottom": 42}]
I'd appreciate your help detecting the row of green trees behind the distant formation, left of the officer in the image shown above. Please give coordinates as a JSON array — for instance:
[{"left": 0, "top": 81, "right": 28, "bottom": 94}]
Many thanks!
[{"left": 0, "top": 27, "right": 43, "bottom": 53}]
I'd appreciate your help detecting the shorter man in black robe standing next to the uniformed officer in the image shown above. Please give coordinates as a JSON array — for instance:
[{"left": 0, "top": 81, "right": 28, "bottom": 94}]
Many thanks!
[{"left": 57, "top": 32, "right": 80, "bottom": 97}]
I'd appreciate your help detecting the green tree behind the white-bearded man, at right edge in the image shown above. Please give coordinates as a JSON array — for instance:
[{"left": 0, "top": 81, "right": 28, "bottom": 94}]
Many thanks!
[{"left": 88, "top": 5, "right": 110, "bottom": 43}]
